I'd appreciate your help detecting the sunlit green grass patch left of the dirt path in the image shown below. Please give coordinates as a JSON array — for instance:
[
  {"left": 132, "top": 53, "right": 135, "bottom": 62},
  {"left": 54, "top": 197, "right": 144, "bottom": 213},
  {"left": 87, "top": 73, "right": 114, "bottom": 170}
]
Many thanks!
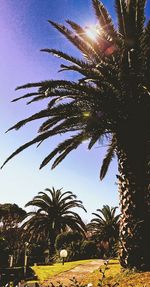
[{"left": 32, "top": 259, "right": 92, "bottom": 282}]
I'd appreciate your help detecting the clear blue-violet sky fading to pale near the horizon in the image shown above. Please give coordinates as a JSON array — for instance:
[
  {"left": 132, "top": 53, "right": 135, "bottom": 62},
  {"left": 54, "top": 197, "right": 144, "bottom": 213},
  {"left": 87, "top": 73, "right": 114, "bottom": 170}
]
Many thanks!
[{"left": 0, "top": 0, "right": 149, "bottom": 223}]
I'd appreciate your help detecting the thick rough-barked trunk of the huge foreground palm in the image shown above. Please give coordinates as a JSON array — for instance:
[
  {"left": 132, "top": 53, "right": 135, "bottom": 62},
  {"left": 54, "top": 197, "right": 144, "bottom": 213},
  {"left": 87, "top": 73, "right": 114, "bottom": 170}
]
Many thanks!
[{"left": 117, "top": 130, "right": 150, "bottom": 270}]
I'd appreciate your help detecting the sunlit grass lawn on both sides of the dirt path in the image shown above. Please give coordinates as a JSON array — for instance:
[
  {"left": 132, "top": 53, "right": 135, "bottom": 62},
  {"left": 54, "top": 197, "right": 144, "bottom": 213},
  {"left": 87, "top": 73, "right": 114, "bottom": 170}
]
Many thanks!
[{"left": 29, "top": 260, "right": 150, "bottom": 287}]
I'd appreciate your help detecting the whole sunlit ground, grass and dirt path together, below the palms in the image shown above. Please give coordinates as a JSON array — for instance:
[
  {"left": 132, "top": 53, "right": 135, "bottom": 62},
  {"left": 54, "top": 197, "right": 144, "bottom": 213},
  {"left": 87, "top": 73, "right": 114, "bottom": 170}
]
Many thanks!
[{"left": 30, "top": 259, "right": 150, "bottom": 287}]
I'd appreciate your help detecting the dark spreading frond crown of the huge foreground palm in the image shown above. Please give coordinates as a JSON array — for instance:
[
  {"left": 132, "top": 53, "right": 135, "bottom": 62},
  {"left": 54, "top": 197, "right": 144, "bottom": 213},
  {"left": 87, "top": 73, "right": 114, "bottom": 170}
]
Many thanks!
[{"left": 1, "top": 0, "right": 150, "bottom": 176}]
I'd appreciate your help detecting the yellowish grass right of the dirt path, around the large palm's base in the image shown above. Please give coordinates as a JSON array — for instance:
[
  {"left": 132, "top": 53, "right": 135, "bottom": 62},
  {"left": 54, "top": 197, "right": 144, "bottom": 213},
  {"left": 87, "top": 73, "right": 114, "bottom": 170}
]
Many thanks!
[{"left": 82, "top": 260, "right": 150, "bottom": 287}]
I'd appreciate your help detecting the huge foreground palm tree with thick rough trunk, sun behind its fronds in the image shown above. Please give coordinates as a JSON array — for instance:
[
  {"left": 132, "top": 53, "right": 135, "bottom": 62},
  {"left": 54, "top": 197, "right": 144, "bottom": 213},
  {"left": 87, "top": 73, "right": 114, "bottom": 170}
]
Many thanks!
[{"left": 4, "top": 0, "right": 150, "bottom": 270}]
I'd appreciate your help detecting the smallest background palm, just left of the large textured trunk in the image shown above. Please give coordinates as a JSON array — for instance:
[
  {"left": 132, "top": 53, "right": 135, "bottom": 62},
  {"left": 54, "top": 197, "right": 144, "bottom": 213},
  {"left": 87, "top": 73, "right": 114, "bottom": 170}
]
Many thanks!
[{"left": 87, "top": 205, "right": 120, "bottom": 255}]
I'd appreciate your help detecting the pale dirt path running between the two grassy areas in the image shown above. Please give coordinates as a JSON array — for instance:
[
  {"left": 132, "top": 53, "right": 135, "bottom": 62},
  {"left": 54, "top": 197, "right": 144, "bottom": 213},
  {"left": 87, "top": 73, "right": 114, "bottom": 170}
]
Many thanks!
[{"left": 42, "top": 260, "right": 103, "bottom": 286}]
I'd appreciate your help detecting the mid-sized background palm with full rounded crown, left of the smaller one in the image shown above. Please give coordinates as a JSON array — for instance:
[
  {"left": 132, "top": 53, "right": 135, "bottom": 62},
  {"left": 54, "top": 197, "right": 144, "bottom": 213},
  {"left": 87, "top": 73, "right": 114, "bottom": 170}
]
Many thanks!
[{"left": 22, "top": 188, "right": 86, "bottom": 255}]
